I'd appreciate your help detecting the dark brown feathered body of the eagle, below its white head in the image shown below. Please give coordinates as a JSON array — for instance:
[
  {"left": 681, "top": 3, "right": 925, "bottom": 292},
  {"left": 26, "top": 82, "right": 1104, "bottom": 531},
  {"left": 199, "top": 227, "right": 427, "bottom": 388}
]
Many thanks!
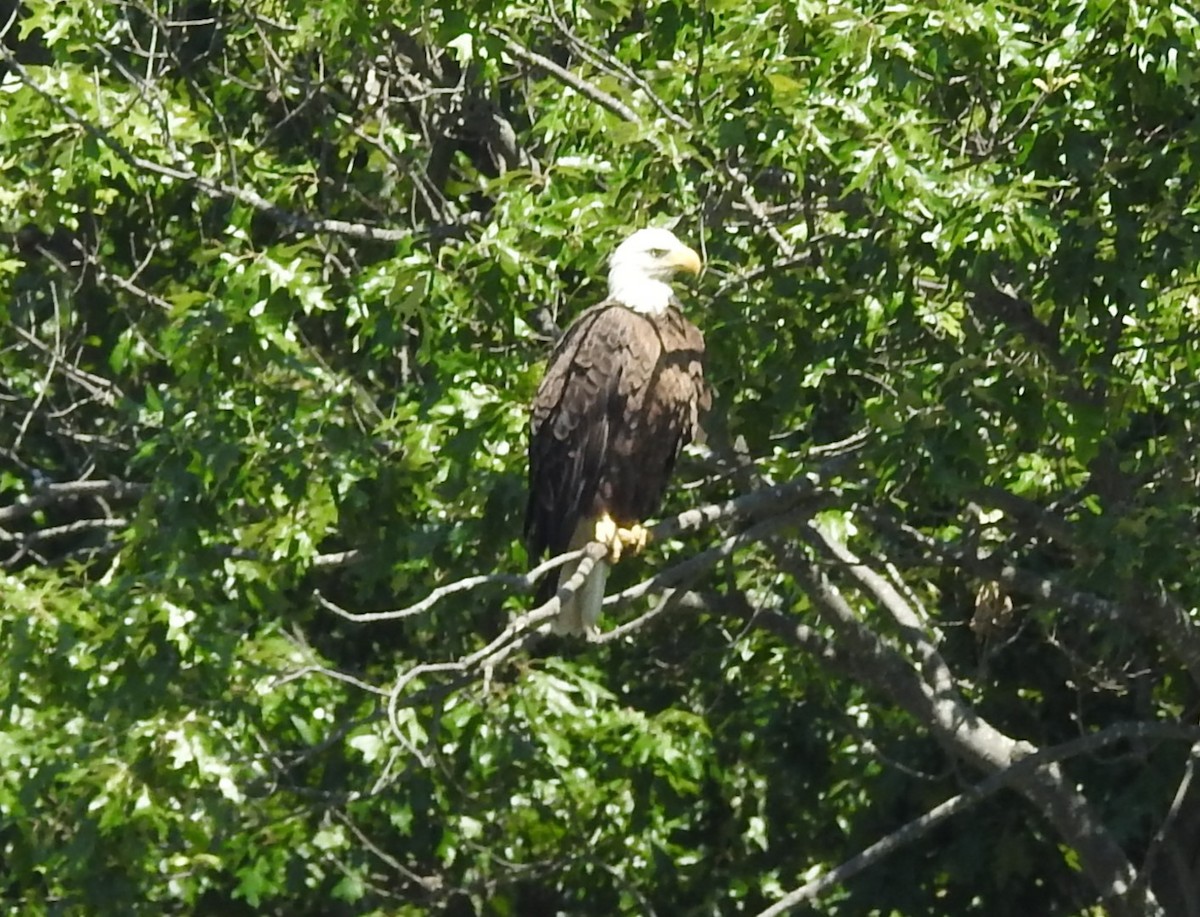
[{"left": 526, "top": 299, "right": 712, "bottom": 633}]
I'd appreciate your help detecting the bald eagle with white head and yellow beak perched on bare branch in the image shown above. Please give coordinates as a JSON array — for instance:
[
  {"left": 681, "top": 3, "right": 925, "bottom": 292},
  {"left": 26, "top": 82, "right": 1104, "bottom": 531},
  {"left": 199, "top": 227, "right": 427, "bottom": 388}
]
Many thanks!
[{"left": 524, "top": 229, "right": 712, "bottom": 635}]
